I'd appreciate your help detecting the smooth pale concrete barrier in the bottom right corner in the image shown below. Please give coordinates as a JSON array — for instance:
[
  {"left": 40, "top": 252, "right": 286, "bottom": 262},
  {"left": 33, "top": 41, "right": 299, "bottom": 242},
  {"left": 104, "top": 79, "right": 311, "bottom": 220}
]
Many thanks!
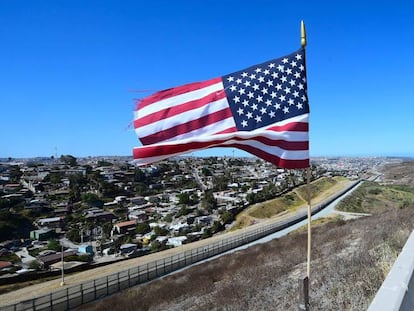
[{"left": 368, "top": 231, "right": 414, "bottom": 311}]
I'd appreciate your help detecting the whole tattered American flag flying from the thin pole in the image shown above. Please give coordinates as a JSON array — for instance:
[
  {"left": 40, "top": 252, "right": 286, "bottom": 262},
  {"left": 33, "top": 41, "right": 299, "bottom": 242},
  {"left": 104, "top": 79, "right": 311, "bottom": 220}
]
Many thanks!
[{"left": 133, "top": 49, "right": 309, "bottom": 169}]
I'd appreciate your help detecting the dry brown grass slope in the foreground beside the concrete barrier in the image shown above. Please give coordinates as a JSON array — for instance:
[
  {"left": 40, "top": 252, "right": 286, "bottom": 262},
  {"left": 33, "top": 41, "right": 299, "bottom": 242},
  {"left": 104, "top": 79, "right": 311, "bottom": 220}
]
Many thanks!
[{"left": 80, "top": 206, "right": 414, "bottom": 311}]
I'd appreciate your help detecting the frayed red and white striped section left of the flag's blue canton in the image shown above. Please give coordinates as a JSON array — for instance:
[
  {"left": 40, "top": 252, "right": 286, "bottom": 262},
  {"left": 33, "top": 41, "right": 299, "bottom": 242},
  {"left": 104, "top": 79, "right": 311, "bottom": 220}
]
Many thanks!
[{"left": 134, "top": 78, "right": 237, "bottom": 145}]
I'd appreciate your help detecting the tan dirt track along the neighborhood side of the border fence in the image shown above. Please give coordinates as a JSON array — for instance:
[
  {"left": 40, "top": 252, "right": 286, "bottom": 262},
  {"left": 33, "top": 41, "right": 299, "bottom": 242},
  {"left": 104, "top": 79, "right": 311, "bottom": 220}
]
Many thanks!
[{"left": 0, "top": 182, "right": 349, "bottom": 307}]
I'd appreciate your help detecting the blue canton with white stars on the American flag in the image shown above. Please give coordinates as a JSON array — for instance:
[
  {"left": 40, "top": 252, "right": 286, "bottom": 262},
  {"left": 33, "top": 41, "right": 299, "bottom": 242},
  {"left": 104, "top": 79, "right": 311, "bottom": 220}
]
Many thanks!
[{"left": 222, "top": 49, "right": 309, "bottom": 131}]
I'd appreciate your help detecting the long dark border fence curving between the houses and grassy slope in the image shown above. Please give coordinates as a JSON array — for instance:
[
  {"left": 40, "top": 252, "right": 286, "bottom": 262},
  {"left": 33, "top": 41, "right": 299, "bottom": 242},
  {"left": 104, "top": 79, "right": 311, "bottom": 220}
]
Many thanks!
[{"left": 0, "top": 181, "right": 360, "bottom": 311}]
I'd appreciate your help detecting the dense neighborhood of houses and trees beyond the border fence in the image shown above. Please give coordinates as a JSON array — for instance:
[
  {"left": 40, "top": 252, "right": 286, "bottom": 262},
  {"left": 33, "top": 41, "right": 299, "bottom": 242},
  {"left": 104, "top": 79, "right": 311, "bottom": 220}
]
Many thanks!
[{"left": 0, "top": 155, "right": 392, "bottom": 278}]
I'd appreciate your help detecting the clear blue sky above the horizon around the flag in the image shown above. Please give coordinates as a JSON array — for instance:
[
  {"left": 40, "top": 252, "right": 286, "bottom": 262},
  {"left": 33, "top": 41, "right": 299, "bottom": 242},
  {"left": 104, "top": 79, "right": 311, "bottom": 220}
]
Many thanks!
[{"left": 0, "top": 0, "right": 414, "bottom": 158}]
